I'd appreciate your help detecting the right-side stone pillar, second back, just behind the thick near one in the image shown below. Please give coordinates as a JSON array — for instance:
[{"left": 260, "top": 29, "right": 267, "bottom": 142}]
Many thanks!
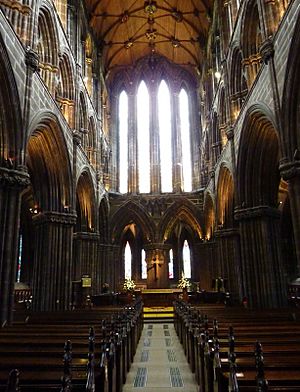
[{"left": 215, "top": 229, "right": 242, "bottom": 303}]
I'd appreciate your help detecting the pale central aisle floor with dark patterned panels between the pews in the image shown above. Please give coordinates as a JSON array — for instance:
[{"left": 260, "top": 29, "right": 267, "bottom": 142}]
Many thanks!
[{"left": 123, "top": 323, "right": 199, "bottom": 392}]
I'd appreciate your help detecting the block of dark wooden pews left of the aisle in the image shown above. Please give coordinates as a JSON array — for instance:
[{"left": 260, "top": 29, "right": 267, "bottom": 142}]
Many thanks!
[{"left": 0, "top": 299, "right": 143, "bottom": 392}]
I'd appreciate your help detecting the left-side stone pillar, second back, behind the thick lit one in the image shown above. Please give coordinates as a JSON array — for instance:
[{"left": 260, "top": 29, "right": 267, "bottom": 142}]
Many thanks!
[{"left": 72, "top": 232, "right": 101, "bottom": 294}]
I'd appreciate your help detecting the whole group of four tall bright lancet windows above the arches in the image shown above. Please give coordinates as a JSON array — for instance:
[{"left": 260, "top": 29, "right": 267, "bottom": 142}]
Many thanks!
[{"left": 118, "top": 79, "right": 192, "bottom": 193}]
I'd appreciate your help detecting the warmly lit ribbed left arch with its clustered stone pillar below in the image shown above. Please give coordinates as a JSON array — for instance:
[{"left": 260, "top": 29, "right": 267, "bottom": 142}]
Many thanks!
[{"left": 26, "top": 113, "right": 76, "bottom": 311}]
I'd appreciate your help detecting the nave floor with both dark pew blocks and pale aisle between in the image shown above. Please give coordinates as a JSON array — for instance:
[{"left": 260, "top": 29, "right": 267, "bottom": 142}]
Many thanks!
[{"left": 0, "top": 299, "right": 300, "bottom": 392}]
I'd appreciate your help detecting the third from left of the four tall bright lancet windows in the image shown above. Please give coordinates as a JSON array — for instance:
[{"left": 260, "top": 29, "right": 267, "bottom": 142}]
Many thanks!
[{"left": 158, "top": 80, "right": 173, "bottom": 192}]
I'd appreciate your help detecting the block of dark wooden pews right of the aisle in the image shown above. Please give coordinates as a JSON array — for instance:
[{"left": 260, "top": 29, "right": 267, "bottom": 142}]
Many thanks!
[{"left": 174, "top": 301, "right": 300, "bottom": 392}]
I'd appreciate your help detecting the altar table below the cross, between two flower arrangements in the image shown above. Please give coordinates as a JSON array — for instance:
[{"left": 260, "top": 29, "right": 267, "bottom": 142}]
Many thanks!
[{"left": 140, "top": 288, "right": 182, "bottom": 307}]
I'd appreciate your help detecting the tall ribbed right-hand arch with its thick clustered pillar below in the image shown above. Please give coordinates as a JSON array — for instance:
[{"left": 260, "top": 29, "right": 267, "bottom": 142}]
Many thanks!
[{"left": 235, "top": 106, "right": 286, "bottom": 308}]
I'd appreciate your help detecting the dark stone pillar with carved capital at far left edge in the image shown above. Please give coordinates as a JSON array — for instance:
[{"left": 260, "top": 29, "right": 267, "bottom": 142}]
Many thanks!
[{"left": 0, "top": 167, "right": 30, "bottom": 326}]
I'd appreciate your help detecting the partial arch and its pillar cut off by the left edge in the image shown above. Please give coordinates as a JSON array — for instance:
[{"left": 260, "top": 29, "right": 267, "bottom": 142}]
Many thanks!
[{"left": 0, "top": 36, "right": 29, "bottom": 325}]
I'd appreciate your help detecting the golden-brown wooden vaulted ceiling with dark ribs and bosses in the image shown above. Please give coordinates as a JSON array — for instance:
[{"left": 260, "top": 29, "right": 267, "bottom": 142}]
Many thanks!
[{"left": 86, "top": 0, "right": 212, "bottom": 77}]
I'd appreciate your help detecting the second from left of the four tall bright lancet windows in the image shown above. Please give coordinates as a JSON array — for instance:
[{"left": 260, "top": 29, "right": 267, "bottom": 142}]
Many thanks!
[{"left": 137, "top": 81, "right": 150, "bottom": 193}]
